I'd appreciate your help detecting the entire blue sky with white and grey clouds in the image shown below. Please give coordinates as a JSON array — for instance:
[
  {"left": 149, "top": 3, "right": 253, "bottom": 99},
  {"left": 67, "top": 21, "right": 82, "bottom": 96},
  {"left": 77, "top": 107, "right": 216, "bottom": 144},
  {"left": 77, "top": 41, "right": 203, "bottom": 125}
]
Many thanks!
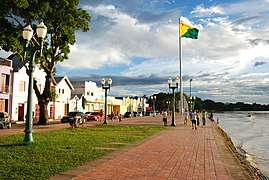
[{"left": 0, "top": 0, "right": 269, "bottom": 104}]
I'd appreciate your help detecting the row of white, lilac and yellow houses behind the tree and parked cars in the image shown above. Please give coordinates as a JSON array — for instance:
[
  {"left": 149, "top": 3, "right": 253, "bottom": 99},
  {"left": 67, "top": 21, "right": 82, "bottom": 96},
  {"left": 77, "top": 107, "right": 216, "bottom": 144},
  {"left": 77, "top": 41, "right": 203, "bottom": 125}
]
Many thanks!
[{"left": 0, "top": 56, "right": 148, "bottom": 122}]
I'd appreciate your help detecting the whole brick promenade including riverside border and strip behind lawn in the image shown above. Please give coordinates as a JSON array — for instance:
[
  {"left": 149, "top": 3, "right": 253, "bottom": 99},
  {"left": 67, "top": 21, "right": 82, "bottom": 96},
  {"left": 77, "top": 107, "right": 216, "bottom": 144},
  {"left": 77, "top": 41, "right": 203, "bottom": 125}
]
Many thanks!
[{"left": 0, "top": 116, "right": 253, "bottom": 180}]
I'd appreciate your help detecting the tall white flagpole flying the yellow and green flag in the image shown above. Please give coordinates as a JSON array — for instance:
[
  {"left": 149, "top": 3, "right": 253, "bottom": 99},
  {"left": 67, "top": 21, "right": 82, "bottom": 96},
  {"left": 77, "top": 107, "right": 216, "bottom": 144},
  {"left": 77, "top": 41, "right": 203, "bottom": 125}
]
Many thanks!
[{"left": 178, "top": 17, "right": 183, "bottom": 115}]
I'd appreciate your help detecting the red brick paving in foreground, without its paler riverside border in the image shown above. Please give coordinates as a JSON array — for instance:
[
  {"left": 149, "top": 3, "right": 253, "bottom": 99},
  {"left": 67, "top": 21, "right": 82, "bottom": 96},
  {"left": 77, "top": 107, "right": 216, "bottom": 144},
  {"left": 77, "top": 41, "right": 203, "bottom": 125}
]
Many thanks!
[{"left": 73, "top": 121, "right": 229, "bottom": 180}]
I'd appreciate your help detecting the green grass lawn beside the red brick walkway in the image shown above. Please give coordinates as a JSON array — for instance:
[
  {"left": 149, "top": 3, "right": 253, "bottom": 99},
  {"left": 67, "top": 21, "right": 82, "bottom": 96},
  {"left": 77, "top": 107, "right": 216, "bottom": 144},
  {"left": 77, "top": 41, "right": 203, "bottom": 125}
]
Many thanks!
[{"left": 0, "top": 125, "right": 167, "bottom": 179}]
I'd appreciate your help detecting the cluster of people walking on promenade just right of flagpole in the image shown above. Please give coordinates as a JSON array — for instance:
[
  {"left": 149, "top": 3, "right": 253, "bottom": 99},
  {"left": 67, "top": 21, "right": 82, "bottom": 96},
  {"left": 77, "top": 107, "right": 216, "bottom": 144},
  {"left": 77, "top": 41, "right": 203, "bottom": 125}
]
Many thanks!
[{"left": 184, "top": 110, "right": 206, "bottom": 130}]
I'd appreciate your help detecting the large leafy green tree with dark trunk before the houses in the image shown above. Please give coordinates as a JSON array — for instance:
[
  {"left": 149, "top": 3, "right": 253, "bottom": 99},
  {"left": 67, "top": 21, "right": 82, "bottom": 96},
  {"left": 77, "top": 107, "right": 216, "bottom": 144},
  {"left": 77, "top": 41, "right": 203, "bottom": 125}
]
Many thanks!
[{"left": 0, "top": 0, "right": 91, "bottom": 124}]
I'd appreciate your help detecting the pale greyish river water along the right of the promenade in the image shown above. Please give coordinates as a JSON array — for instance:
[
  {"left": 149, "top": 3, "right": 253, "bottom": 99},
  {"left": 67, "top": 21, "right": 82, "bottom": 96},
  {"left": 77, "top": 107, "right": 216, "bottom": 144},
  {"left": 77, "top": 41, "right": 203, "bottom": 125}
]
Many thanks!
[{"left": 214, "top": 111, "right": 269, "bottom": 177}]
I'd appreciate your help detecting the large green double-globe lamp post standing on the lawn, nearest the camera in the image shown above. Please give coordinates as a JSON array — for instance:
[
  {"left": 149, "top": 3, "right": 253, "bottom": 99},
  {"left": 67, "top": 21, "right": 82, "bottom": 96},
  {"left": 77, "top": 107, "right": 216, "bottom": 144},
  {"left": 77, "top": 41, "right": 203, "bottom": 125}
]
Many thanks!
[{"left": 22, "top": 22, "right": 47, "bottom": 144}]
